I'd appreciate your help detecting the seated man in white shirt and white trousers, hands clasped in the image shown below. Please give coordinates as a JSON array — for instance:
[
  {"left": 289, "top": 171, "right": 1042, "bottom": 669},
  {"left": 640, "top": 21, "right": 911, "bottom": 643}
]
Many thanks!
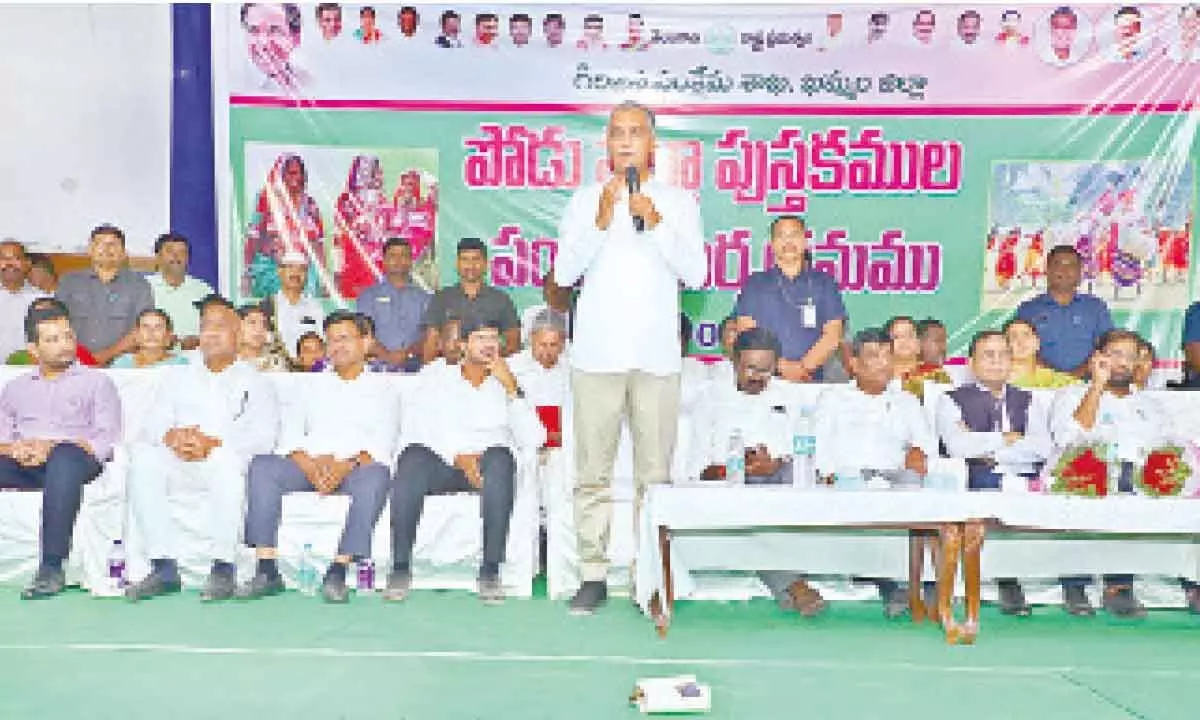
[{"left": 125, "top": 295, "right": 278, "bottom": 601}]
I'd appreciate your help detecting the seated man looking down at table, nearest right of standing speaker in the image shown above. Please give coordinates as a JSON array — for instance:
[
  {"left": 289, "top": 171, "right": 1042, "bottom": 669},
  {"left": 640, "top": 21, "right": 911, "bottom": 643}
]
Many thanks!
[{"left": 698, "top": 328, "right": 824, "bottom": 617}]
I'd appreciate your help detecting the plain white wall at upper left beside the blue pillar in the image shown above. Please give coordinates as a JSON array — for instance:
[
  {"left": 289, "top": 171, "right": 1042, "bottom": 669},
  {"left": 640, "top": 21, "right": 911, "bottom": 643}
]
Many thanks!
[{"left": 0, "top": 4, "right": 172, "bottom": 254}]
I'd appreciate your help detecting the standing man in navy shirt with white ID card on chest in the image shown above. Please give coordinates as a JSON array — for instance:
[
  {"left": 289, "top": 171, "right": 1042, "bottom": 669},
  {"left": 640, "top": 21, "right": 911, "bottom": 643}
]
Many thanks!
[{"left": 733, "top": 215, "right": 847, "bottom": 383}]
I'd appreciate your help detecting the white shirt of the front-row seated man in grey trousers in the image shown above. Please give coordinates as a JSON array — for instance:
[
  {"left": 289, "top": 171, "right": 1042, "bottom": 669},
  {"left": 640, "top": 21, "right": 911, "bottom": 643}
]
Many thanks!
[{"left": 278, "top": 370, "right": 400, "bottom": 467}]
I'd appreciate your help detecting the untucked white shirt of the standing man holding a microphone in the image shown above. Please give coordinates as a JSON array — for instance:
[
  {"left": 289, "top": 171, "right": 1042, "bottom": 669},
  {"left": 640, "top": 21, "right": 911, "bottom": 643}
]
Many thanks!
[{"left": 554, "top": 179, "right": 708, "bottom": 376}]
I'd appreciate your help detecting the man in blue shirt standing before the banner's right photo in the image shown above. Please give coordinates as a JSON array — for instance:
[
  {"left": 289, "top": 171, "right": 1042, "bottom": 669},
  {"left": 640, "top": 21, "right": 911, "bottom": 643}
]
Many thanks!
[{"left": 1016, "top": 245, "right": 1112, "bottom": 377}]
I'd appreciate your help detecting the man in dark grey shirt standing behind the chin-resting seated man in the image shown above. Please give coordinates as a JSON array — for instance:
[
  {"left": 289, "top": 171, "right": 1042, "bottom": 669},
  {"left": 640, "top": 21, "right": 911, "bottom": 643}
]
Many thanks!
[{"left": 421, "top": 238, "right": 521, "bottom": 362}]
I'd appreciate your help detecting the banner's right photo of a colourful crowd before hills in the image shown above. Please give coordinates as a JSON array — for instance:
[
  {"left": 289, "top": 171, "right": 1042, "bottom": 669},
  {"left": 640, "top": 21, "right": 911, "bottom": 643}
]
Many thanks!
[{"left": 983, "top": 158, "right": 1195, "bottom": 310}]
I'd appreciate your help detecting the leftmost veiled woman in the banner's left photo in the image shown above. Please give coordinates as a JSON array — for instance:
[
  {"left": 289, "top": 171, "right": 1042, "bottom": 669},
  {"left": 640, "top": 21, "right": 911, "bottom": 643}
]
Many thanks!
[{"left": 241, "top": 152, "right": 326, "bottom": 298}]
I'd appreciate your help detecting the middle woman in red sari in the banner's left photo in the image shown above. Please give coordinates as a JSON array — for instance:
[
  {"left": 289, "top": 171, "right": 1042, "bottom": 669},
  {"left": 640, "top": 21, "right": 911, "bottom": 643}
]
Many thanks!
[{"left": 334, "top": 155, "right": 391, "bottom": 300}]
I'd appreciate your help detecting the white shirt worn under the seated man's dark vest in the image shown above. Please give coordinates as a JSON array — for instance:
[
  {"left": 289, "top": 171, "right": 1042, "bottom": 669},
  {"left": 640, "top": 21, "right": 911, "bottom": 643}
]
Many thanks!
[{"left": 937, "top": 386, "right": 1051, "bottom": 475}]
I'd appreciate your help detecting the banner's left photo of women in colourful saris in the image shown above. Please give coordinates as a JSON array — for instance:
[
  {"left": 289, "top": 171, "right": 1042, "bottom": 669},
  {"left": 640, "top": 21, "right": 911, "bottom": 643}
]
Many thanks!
[{"left": 236, "top": 143, "right": 438, "bottom": 301}]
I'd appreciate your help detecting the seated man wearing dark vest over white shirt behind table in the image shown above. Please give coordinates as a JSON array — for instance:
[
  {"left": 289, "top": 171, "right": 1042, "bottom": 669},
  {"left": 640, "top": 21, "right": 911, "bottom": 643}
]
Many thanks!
[{"left": 937, "top": 330, "right": 1050, "bottom": 616}]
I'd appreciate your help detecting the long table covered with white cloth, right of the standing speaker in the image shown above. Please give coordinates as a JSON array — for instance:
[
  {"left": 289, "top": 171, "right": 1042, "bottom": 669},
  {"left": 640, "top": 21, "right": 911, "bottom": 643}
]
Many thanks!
[{"left": 637, "top": 486, "right": 1200, "bottom": 630}]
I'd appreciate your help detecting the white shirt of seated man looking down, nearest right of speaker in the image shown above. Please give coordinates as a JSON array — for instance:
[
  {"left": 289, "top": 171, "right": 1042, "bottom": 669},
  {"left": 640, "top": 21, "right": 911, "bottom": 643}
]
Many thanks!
[{"left": 696, "top": 382, "right": 794, "bottom": 469}]
